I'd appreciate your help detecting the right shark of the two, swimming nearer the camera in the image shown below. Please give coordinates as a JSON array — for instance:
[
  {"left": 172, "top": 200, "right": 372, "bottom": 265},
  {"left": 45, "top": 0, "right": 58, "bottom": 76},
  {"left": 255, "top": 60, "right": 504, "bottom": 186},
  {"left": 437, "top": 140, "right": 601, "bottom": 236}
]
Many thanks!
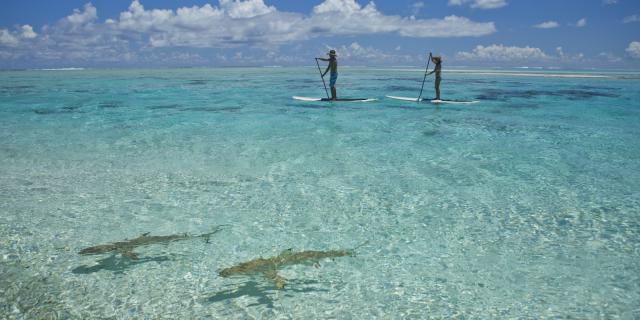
[{"left": 218, "top": 242, "right": 366, "bottom": 289}]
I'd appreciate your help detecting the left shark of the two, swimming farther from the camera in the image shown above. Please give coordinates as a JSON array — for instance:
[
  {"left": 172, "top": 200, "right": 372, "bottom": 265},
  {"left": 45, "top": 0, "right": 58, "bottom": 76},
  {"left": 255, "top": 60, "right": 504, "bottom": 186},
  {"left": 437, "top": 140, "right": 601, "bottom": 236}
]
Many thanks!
[{"left": 79, "top": 226, "right": 222, "bottom": 260}]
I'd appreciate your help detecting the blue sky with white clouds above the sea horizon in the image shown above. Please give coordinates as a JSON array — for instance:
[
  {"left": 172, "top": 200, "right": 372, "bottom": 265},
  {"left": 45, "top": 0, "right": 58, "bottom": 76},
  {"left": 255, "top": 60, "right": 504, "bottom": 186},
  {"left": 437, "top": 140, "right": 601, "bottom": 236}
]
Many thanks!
[{"left": 0, "top": 0, "right": 640, "bottom": 70}]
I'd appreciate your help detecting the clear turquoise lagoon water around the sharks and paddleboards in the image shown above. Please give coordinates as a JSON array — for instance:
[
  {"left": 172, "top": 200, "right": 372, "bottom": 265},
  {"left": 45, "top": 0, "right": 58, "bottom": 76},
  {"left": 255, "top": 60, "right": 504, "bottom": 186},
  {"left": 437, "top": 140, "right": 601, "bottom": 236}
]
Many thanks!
[{"left": 0, "top": 68, "right": 640, "bottom": 319}]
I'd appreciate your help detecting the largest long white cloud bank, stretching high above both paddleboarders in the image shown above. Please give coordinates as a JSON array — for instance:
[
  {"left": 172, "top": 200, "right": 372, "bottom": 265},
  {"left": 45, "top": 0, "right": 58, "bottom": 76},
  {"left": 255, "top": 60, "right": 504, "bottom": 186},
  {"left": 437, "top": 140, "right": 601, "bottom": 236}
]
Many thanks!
[{"left": 110, "top": 0, "right": 496, "bottom": 47}]
